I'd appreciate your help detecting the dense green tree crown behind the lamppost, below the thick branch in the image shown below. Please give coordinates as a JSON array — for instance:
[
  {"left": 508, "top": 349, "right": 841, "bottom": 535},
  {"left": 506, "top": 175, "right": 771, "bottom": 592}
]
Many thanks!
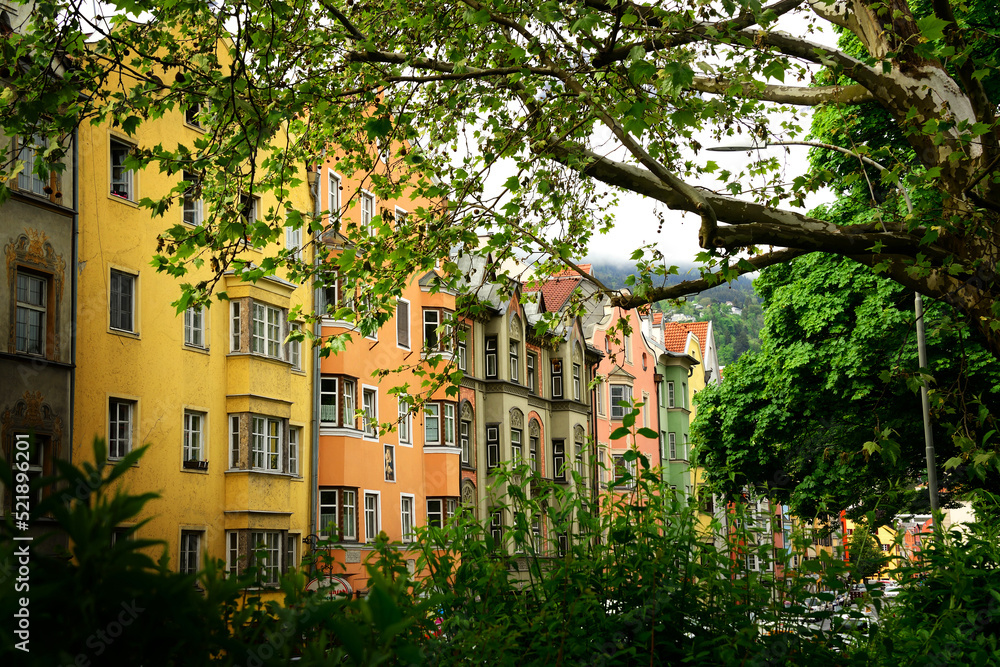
[{"left": 692, "top": 253, "right": 1000, "bottom": 521}]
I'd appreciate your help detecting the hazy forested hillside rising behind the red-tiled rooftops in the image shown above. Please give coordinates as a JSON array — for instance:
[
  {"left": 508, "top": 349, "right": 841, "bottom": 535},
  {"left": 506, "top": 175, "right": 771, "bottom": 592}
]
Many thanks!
[{"left": 593, "top": 263, "right": 764, "bottom": 365}]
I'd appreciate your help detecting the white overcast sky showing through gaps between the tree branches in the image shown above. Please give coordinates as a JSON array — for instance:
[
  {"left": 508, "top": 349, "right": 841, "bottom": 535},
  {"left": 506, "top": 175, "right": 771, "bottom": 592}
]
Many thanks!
[{"left": 585, "top": 15, "right": 836, "bottom": 266}]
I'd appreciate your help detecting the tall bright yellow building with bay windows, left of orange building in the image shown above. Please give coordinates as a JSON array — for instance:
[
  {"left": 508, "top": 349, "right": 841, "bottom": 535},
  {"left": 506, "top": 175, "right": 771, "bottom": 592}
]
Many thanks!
[{"left": 73, "top": 100, "right": 313, "bottom": 581}]
